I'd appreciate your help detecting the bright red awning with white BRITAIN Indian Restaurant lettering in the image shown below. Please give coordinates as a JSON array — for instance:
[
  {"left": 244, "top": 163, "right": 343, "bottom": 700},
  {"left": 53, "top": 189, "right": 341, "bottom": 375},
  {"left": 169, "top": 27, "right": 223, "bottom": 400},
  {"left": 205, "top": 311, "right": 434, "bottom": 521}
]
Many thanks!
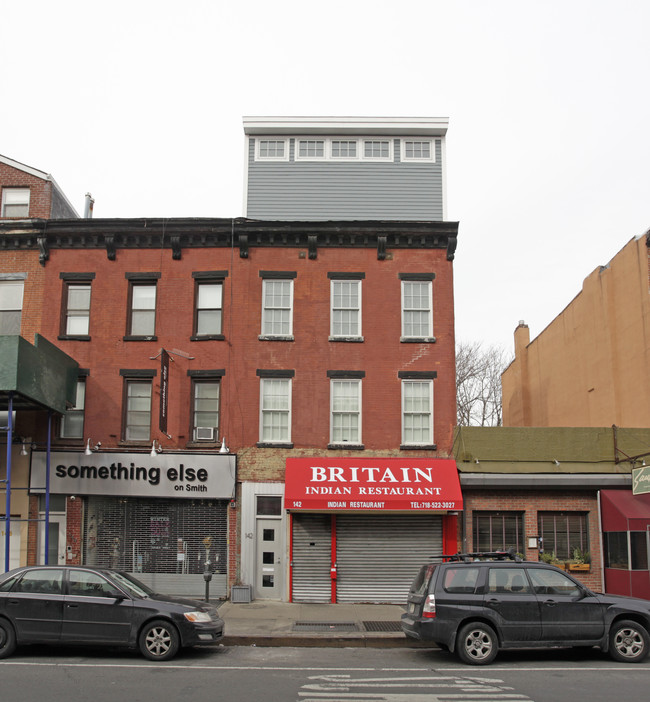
[{"left": 284, "top": 457, "right": 463, "bottom": 512}]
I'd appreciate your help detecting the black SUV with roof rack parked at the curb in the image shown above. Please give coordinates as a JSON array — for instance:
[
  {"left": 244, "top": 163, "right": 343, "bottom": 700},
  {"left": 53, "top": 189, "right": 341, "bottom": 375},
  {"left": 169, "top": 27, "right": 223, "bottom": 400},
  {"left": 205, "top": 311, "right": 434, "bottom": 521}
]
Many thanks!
[{"left": 402, "top": 552, "right": 650, "bottom": 665}]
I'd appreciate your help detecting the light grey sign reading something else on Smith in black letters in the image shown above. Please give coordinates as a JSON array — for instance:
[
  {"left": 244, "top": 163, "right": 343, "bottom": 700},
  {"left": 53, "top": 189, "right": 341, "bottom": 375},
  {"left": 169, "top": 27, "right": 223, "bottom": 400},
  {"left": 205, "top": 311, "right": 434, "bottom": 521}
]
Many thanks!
[{"left": 30, "top": 451, "right": 236, "bottom": 499}]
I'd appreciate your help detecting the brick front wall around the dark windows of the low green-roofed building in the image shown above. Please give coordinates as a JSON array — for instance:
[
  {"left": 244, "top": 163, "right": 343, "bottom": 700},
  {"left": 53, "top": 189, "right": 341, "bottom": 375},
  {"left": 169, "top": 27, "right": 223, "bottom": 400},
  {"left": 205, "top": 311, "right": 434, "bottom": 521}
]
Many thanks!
[{"left": 460, "top": 490, "right": 603, "bottom": 591}]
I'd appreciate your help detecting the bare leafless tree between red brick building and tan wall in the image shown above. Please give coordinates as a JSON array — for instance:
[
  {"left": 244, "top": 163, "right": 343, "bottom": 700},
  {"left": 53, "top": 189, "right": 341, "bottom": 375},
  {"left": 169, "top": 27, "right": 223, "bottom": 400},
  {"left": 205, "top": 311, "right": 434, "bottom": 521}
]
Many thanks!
[{"left": 456, "top": 341, "right": 510, "bottom": 427}]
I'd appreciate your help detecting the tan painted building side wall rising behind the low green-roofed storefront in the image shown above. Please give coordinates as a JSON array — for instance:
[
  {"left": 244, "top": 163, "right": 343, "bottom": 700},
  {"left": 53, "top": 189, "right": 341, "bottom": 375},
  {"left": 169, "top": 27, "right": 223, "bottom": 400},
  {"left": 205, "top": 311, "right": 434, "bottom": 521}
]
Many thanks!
[{"left": 502, "top": 235, "right": 650, "bottom": 427}]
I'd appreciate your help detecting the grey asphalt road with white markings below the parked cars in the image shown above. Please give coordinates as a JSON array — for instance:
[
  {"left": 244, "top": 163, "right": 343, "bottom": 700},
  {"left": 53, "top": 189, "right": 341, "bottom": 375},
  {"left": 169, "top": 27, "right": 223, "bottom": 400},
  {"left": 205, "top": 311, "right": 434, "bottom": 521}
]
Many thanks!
[{"left": 0, "top": 646, "right": 650, "bottom": 702}]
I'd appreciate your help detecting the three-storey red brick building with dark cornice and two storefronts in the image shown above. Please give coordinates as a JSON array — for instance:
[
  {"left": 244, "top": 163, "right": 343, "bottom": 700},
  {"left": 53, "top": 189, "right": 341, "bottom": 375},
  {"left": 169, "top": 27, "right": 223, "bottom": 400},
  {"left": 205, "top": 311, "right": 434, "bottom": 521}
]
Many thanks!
[{"left": 0, "top": 219, "right": 462, "bottom": 601}]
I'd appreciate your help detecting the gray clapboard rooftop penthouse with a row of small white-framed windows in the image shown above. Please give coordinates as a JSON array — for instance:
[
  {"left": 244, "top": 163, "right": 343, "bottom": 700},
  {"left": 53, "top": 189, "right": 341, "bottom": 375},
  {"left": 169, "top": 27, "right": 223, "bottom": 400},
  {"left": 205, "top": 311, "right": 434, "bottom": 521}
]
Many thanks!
[{"left": 243, "top": 117, "right": 449, "bottom": 221}]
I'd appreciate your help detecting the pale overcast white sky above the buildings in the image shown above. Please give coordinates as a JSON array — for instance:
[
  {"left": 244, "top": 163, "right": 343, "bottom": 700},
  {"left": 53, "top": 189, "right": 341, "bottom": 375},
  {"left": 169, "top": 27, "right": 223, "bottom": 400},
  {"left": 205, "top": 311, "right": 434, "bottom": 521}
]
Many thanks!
[{"left": 0, "top": 0, "right": 650, "bottom": 354}]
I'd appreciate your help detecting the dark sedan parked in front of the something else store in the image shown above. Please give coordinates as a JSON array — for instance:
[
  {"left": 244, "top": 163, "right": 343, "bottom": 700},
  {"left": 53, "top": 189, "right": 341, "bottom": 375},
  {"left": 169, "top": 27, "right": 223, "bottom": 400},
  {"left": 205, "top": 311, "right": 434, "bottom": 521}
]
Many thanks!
[{"left": 0, "top": 566, "right": 224, "bottom": 661}]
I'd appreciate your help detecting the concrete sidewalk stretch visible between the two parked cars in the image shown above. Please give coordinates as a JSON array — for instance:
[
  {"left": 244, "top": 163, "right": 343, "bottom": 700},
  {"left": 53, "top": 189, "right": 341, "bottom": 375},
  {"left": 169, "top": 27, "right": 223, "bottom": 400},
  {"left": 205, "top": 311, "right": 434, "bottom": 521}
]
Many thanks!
[{"left": 217, "top": 600, "right": 432, "bottom": 648}]
